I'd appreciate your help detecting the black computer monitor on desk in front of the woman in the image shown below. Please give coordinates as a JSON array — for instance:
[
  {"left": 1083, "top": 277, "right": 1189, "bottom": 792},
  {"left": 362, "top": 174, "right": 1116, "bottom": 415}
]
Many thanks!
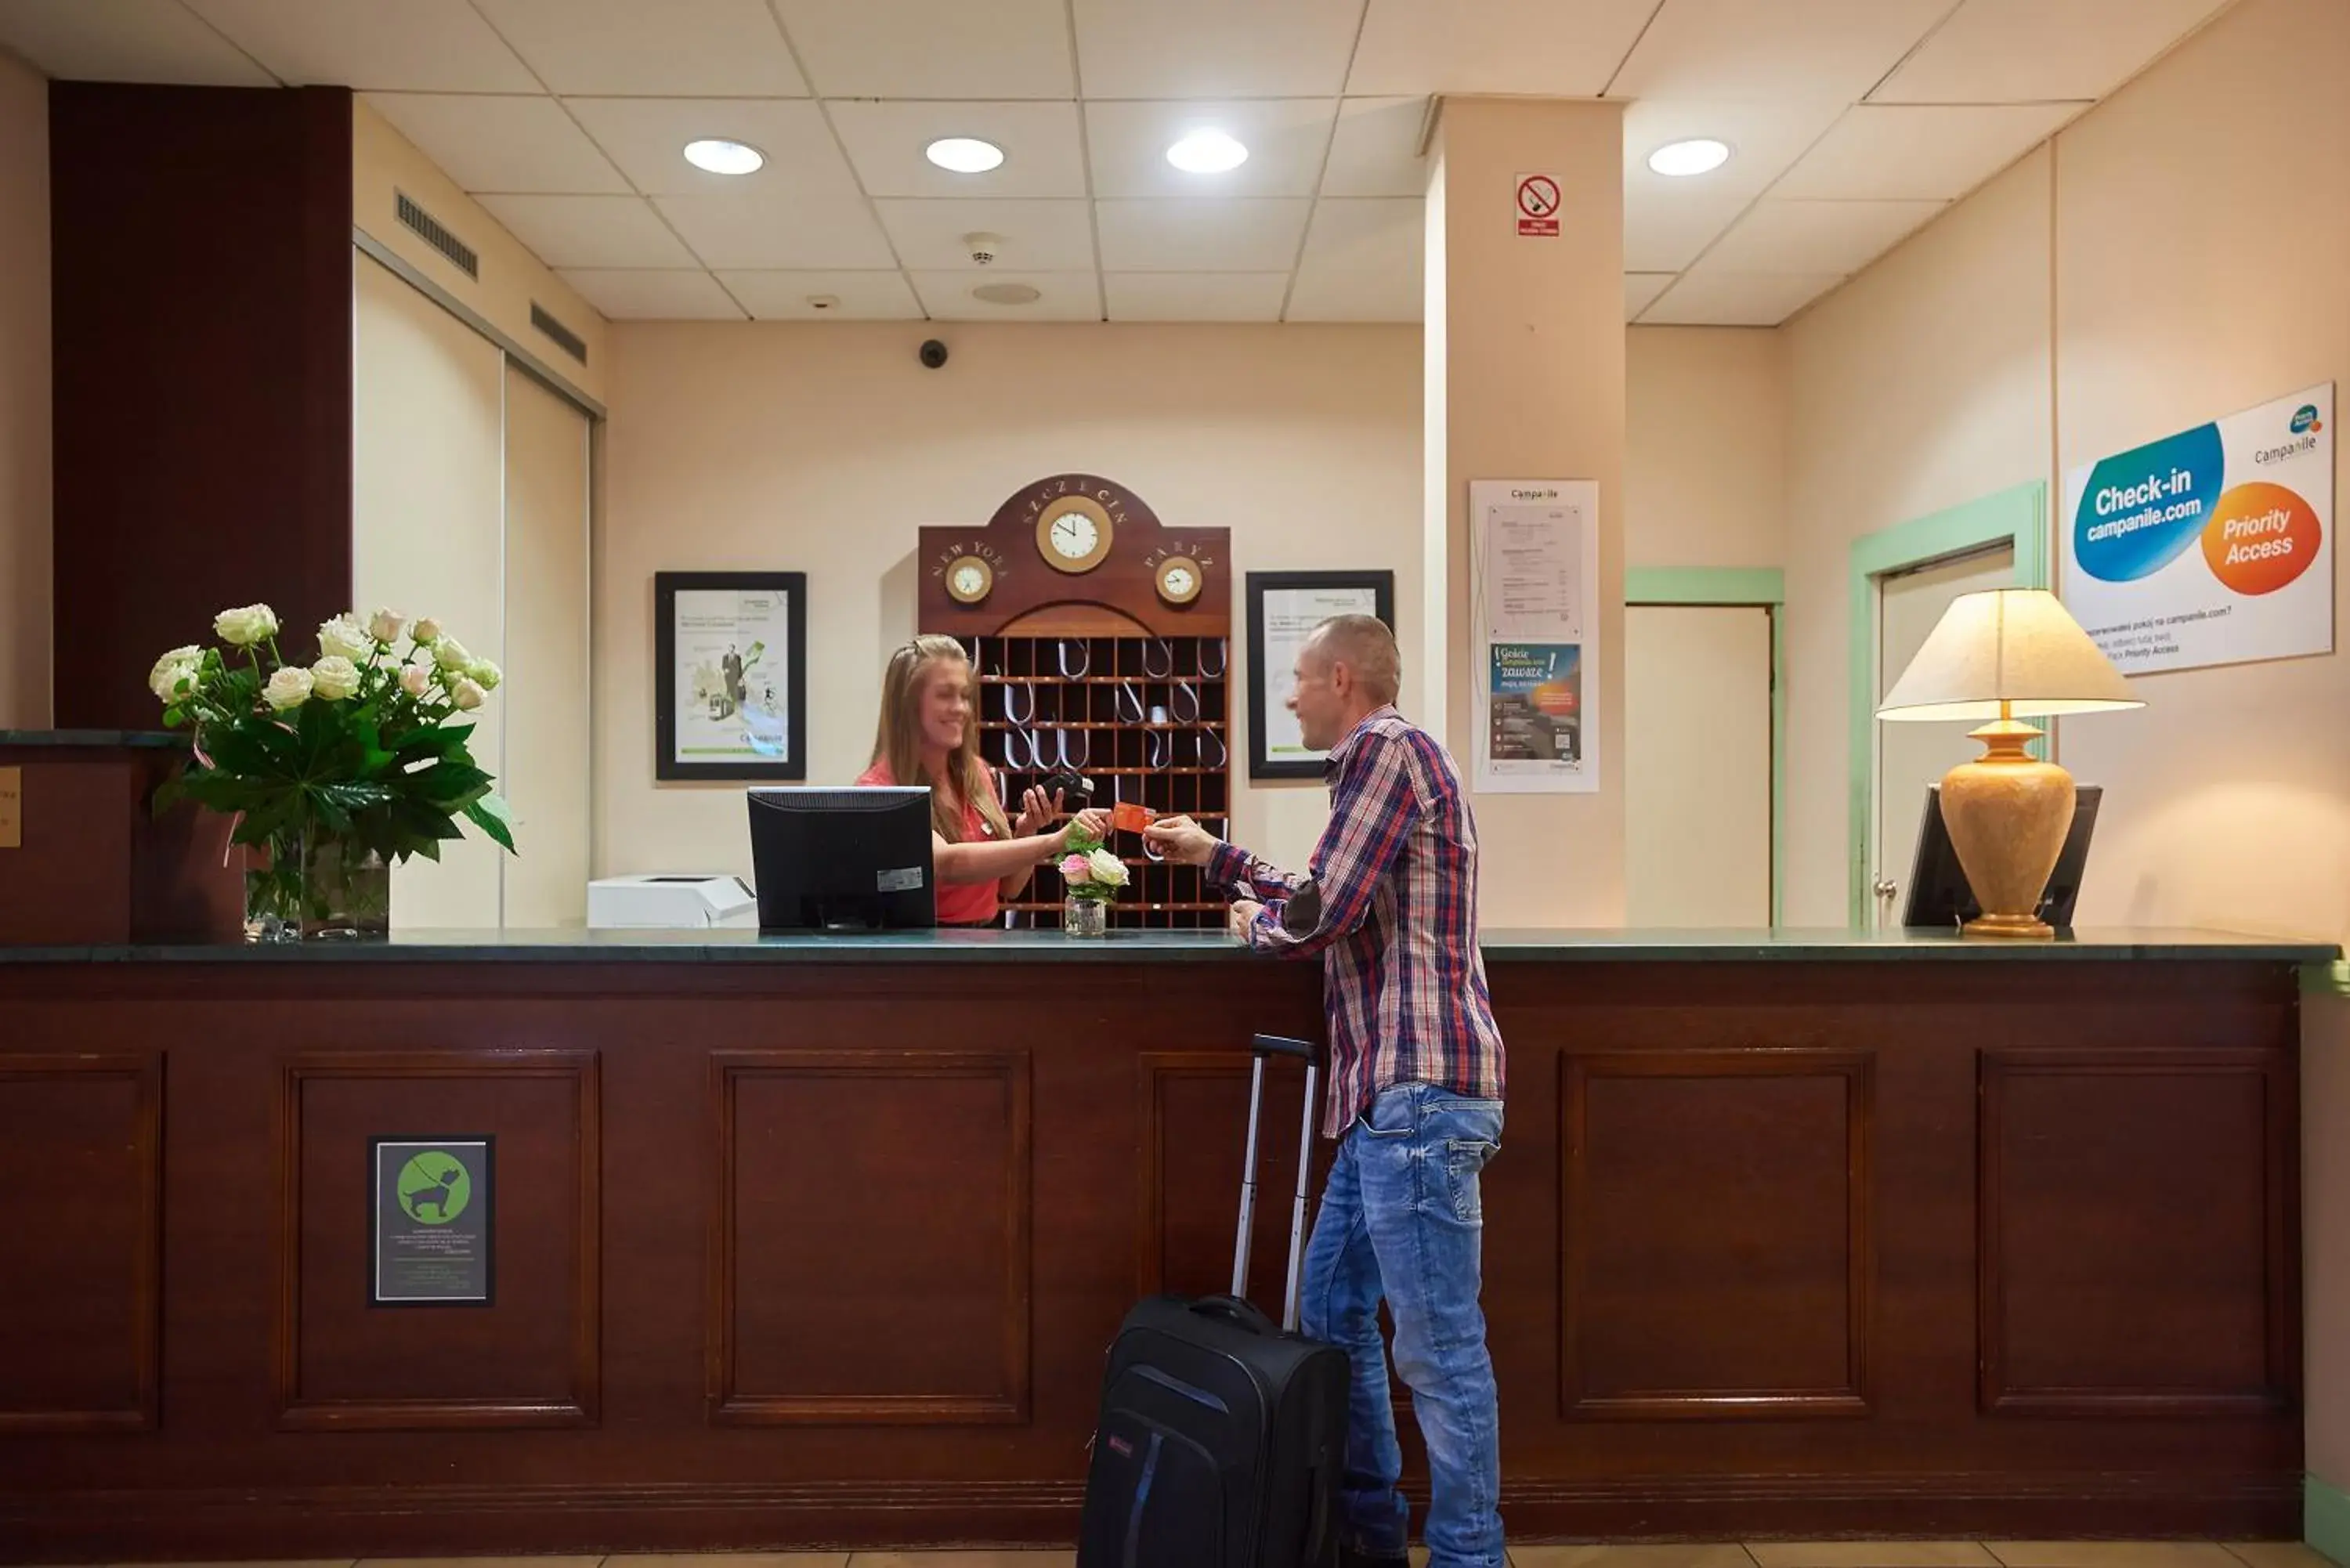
[{"left": 750, "top": 786, "right": 938, "bottom": 931}]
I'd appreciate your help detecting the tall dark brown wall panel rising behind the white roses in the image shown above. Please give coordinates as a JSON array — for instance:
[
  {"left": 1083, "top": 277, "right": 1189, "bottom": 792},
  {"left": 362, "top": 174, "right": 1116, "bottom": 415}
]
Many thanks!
[{"left": 49, "top": 82, "right": 350, "bottom": 728}]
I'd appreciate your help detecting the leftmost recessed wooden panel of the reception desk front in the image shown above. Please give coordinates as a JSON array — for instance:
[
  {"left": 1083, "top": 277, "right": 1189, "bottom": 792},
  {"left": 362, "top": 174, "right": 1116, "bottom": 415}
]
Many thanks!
[{"left": 0, "top": 1056, "right": 162, "bottom": 1436}]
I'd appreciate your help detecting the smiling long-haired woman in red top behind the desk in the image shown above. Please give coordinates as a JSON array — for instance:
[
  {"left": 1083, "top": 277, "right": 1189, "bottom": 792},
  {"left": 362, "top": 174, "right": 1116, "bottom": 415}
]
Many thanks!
[{"left": 858, "top": 637, "right": 1109, "bottom": 927}]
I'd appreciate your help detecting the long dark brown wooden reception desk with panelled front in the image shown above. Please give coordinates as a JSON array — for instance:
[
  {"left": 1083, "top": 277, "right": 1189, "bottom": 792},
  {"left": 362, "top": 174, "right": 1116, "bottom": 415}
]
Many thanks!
[{"left": 0, "top": 931, "right": 2338, "bottom": 1563}]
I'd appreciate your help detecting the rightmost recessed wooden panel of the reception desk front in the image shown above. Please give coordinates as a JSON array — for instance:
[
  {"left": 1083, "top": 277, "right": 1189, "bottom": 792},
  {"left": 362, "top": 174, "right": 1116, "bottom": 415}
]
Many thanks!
[{"left": 1981, "top": 1051, "right": 2298, "bottom": 1415}]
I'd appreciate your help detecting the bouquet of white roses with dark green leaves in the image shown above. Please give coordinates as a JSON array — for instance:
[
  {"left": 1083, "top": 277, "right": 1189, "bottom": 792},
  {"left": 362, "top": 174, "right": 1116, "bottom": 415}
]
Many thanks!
[{"left": 148, "top": 604, "right": 515, "bottom": 924}]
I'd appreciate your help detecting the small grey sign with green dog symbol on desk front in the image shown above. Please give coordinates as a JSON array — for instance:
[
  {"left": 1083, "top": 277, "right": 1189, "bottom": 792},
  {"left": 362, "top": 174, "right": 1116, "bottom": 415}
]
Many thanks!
[{"left": 369, "top": 1136, "right": 496, "bottom": 1307}]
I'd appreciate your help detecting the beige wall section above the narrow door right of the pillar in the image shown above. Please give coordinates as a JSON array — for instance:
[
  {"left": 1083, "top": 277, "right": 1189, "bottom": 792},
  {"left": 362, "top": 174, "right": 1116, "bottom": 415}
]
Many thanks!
[{"left": 1624, "top": 327, "right": 1786, "bottom": 566}]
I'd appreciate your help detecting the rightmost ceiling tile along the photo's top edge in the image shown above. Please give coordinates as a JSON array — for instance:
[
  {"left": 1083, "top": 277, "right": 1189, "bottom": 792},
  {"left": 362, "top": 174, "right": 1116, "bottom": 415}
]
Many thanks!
[{"left": 1868, "top": 0, "right": 2223, "bottom": 103}]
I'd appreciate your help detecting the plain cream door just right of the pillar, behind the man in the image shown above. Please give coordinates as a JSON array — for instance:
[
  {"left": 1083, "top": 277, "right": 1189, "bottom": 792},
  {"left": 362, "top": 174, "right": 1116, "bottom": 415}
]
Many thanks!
[{"left": 1624, "top": 604, "right": 1772, "bottom": 929}]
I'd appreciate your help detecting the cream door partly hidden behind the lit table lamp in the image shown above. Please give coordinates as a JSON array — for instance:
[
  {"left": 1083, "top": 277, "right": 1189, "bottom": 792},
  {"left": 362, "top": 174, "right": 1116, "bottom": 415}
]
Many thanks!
[{"left": 1868, "top": 545, "right": 2016, "bottom": 927}]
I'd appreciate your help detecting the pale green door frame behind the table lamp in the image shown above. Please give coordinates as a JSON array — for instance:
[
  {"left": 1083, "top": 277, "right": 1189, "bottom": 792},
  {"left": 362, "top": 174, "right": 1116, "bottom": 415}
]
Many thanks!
[{"left": 1845, "top": 479, "right": 2049, "bottom": 931}]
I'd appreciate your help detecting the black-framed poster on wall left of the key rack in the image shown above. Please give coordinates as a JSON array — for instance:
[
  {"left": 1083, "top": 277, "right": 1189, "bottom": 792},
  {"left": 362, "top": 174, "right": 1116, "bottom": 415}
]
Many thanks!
[{"left": 653, "top": 571, "right": 808, "bottom": 780}]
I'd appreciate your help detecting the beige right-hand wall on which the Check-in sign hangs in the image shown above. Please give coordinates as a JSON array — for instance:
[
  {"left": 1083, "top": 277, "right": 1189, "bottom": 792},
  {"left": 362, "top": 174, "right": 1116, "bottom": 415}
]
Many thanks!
[{"left": 1786, "top": 0, "right": 2350, "bottom": 1486}]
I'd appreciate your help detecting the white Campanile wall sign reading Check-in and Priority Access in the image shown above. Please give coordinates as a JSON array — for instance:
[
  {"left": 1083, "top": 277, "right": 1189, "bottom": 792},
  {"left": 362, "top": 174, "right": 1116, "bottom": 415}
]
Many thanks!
[{"left": 2063, "top": 383, "right": 2334, "bottom": 674}]
